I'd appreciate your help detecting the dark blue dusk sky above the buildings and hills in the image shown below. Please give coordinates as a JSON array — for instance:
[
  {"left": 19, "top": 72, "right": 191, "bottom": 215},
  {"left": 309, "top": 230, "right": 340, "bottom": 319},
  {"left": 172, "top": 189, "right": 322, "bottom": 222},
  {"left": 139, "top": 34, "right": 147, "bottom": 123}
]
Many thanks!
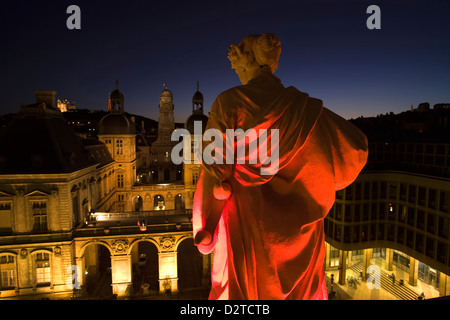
[{"left": 0, "top": 0, "right": 450, "bottom": 122}]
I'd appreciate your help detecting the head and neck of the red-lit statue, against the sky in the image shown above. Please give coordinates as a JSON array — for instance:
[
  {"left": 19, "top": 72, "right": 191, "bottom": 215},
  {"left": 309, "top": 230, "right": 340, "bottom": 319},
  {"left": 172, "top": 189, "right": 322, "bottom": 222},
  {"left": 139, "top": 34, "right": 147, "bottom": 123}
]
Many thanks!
[{"left": 228, "top": 33, "right": 281, "bottom": 84}]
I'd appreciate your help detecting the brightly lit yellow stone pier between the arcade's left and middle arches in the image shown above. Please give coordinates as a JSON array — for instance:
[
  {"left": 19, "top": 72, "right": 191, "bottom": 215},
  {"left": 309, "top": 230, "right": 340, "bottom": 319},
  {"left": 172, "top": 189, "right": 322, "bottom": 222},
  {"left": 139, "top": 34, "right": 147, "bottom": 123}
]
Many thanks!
[{"left": 111, "top": 254, "right": 132, "bottom": 297}]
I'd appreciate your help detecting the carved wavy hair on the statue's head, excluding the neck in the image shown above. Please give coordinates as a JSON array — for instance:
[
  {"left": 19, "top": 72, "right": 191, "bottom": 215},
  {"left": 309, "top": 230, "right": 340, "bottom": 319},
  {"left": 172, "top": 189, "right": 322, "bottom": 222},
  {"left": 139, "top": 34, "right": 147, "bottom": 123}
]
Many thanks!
[{"left": 228, "top": 33, "right": 281, "bottom": 73}]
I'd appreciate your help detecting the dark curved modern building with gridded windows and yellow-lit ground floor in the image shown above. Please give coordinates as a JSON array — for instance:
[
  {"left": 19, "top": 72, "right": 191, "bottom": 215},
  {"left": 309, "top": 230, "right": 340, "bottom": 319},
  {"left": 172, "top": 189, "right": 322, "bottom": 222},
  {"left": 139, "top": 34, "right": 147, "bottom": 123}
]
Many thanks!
[{"left": 325, "top": 108, "right": 450, "bottom": 296}]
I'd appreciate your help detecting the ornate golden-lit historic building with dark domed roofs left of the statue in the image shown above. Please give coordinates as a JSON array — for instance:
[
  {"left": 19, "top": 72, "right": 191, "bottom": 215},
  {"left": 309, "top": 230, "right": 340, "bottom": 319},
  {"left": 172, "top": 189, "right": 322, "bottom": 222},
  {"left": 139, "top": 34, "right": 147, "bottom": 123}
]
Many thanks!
[{"left": 0, "top": 85, "right": 211, "bottom": 298}]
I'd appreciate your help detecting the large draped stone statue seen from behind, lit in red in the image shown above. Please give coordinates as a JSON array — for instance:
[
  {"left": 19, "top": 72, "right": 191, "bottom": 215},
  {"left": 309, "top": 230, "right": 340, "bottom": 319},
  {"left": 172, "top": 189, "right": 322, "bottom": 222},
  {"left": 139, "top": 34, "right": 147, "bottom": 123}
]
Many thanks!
[{"left": 193, "top": 34, "right": 368, "bottom": 300}]
